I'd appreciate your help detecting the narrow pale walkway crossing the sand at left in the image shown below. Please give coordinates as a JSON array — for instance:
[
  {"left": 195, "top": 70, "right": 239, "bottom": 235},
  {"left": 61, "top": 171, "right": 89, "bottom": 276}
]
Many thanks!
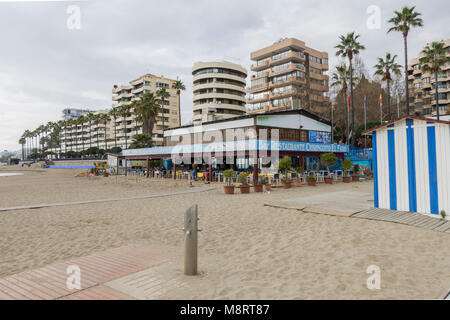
[{"left": 0, "top": 187, "right": 215, "bottom": 212}]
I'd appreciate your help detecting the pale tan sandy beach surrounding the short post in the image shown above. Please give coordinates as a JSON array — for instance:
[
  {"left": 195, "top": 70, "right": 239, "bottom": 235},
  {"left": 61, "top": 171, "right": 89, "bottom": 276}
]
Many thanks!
[{"left": 0, "top": 168, "right": 450, "bottom": 299}]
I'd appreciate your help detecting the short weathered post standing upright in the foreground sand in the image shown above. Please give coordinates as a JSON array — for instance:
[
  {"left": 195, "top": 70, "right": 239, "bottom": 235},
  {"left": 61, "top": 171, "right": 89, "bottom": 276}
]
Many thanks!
[{"left": 183, "top": 204, "right": 201, "bottom": 276}]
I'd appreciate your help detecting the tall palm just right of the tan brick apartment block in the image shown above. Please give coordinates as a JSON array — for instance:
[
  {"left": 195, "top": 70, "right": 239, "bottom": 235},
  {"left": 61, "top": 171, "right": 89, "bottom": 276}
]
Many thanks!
[{"left": 335, "top": 32, "right": 365, "bottom": 142}]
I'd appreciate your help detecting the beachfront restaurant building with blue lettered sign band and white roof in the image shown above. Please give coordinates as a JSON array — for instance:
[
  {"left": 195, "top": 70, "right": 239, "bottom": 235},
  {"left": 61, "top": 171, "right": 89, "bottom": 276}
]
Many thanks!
[{"left": 122, "top": 110, "right": 349, "bottom": 180}]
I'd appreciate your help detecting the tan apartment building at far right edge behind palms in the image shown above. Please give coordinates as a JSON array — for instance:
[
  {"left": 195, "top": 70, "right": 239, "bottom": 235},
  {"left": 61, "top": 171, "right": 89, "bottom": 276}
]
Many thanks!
[{"left": 408, "top": 39, "right": 450, "bottom": 116}]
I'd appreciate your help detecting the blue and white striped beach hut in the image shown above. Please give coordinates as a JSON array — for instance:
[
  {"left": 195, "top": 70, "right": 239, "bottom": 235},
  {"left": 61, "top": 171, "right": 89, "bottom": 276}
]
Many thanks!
[{"left": 364, "top": 116, "right": 450, "bottom": 216}]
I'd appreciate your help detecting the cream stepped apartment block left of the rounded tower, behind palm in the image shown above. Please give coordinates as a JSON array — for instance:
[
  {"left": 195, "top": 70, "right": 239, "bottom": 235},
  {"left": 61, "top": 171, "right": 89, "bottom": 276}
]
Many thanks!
[{"left": 112, "top": 74, "right": 180, "bottom": 148}]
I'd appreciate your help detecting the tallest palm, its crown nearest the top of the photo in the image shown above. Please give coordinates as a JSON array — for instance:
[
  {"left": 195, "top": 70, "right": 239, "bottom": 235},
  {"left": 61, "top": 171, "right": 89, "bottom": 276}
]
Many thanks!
[{"left": 388, "top": 7, "right": 423, "bottom": 115}]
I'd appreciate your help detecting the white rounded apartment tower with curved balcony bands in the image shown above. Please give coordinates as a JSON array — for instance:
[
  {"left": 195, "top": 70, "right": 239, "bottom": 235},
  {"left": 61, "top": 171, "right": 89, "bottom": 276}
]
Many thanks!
[{"left": 192, "top": 61, "right": 247, "bottom": 123}]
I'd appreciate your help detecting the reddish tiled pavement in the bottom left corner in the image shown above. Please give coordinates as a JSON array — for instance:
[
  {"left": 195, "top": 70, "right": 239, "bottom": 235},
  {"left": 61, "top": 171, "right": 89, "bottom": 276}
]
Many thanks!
[{"left": 0, "top": 246, "right": 167, "bottom": 300}]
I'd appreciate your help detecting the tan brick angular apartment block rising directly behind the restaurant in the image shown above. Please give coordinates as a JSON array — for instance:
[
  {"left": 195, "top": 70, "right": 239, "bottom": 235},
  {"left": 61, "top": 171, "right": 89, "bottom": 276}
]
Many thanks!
[{"left": 247, "top": 38, "right": 330, "bottom": 114}]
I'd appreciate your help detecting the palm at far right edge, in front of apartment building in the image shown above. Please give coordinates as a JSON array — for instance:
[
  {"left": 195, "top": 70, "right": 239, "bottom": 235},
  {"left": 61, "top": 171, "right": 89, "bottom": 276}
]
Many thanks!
[{"left": 420, "top": 42, "right": 450, "bottom": 120}]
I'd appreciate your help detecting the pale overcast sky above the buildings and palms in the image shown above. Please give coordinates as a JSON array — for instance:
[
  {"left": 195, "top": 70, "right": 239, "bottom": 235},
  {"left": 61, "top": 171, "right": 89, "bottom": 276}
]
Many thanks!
[{"left": 0, "top": 0, "right": 450, "bottom": 151}]
